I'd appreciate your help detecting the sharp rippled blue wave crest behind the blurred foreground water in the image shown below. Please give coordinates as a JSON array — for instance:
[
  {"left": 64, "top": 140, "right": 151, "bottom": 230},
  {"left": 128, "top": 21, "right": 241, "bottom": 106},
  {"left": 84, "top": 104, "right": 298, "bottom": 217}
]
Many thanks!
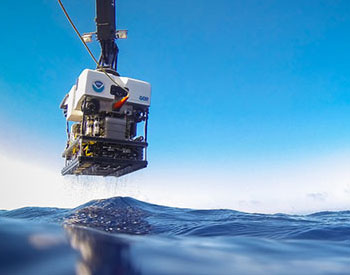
[{"left": 0, "top": 197, "right": 350, "bottom": 241}]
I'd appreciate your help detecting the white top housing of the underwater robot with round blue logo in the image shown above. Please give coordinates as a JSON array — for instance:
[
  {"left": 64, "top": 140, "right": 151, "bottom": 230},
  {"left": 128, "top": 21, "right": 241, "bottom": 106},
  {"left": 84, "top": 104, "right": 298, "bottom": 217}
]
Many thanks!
[{"left": 65, "top": 69, "right": 151, "bottom": 121}]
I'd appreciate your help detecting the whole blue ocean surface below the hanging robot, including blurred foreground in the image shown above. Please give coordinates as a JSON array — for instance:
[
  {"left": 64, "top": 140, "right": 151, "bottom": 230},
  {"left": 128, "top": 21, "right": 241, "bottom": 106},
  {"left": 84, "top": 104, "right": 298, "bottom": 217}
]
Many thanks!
[{"left": 0, "top": 197, "right": 350, "bottom": 275}]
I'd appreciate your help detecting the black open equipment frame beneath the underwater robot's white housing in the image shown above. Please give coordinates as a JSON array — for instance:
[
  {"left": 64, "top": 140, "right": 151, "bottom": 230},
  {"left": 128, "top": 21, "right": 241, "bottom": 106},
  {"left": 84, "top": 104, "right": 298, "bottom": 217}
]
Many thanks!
[{"left": 61, "top": 91, "right": 149, "bottom": 177}]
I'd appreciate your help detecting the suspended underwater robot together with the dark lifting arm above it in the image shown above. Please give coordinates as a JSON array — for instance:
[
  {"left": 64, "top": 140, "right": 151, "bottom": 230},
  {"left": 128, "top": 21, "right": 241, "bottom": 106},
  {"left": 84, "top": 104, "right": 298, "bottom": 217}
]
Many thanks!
[{"left": 59, "top": 0, "right": 151, "bottom": 177}]
